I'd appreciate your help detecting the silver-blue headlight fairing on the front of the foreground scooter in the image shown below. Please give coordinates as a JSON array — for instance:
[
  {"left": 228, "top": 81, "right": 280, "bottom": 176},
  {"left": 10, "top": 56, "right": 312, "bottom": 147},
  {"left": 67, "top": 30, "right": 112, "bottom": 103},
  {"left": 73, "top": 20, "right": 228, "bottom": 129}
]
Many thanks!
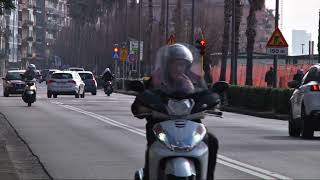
[{"left": 153, "top": 120, "right": 207, "bottom": 151}]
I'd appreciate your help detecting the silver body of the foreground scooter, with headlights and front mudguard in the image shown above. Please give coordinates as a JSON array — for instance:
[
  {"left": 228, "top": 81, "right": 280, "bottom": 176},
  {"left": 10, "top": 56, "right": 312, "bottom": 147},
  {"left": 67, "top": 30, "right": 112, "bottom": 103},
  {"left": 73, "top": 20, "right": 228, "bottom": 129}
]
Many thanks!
[{"left": 135, "top": 100, "right": 209, "bottom": 180}]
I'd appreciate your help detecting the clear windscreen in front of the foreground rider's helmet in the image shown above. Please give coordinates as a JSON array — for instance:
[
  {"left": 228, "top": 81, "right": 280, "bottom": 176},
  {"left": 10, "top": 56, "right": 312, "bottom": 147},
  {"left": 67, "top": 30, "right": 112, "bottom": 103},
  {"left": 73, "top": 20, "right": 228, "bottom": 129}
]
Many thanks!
[{"left": 152, "top": 44, "right": 207, "bottom": 98}]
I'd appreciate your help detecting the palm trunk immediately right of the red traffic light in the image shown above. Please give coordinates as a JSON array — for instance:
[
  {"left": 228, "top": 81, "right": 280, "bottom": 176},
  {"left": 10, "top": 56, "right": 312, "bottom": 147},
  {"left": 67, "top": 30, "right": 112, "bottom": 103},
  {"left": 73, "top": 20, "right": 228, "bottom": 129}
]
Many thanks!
[{"left": 220, "top": 0, "right": 231, "bottom": 81}]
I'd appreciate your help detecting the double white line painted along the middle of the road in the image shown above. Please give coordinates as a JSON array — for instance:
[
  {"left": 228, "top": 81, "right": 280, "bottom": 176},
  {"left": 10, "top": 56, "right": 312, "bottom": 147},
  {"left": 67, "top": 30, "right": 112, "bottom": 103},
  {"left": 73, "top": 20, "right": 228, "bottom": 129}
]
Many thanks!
[{"left": 52, "top": 101, "right": 292, "bottom": 180}]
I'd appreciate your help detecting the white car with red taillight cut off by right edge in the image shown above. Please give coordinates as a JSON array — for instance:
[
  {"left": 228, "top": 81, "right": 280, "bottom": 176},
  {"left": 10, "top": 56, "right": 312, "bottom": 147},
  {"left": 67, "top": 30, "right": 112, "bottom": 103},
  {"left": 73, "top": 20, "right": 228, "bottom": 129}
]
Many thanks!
[{"left": 289, "top": 64, "right": 320, "bottom": 138}]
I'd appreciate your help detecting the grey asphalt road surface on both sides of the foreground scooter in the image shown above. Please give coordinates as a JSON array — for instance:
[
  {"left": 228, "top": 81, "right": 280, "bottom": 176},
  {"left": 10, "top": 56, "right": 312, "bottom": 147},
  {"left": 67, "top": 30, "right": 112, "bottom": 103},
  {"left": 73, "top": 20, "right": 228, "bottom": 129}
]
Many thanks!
[{"left": 0, "top": 82, "right": 320, "bottom": 179}]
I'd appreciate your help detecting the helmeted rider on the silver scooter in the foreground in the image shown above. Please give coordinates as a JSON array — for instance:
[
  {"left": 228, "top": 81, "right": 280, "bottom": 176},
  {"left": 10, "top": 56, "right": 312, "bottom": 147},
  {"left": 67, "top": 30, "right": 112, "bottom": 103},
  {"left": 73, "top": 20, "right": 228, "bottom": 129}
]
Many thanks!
[{"left": 131, "top": 44, "right": 218, "bottom": 180}]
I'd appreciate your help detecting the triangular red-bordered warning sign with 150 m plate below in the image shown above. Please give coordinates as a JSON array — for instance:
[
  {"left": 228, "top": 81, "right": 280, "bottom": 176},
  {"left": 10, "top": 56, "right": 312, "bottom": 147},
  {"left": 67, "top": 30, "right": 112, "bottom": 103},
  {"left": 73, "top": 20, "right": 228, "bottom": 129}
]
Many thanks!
[{"left": 266, "top": 28, "right": 288, "bottom": 55}]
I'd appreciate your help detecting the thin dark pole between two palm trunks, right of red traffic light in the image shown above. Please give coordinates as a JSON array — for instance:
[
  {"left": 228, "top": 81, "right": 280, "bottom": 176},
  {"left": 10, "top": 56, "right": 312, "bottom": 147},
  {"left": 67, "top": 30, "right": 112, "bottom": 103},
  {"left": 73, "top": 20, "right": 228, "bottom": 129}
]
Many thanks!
[{"left": 230, "top": 0, "right": 237, "bottom": 84}]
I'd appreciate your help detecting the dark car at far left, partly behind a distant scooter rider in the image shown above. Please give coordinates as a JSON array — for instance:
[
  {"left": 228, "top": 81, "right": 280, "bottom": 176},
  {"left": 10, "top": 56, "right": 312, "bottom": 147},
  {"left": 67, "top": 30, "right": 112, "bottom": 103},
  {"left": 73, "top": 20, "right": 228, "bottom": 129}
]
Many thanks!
[{"left": 2, "top": 70, "right": 25, "bottom": 97}]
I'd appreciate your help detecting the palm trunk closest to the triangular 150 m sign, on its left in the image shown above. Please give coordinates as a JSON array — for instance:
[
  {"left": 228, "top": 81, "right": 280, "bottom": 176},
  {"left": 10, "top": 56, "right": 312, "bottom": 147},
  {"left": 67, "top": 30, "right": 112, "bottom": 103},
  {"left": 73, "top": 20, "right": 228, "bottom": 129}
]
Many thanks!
[{"left": 246, "top": 4, "right": 257, "bottom": 86}]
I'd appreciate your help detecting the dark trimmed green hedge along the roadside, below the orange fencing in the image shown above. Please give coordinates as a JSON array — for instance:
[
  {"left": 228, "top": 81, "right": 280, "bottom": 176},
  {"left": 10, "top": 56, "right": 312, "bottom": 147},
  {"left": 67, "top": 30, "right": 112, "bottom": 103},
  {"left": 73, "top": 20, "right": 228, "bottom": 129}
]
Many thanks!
[{"left": 227, "top": 86, "right": 293, "bottom": 114}]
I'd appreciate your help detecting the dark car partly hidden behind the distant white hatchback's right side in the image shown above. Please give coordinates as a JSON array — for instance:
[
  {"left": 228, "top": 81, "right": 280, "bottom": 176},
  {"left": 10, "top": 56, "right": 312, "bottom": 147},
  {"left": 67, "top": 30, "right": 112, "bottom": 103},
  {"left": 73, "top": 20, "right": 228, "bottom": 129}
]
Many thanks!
[{"left": 78, "top": 71, "right": 97, "bottom": 95}]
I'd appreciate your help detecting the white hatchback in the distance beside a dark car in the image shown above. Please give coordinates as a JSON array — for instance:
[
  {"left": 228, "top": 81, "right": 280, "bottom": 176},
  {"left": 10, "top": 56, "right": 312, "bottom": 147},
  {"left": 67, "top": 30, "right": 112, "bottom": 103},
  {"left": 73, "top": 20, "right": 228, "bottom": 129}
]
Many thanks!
[{"left": 47, "top": 71, "right": 85, "bottom": 98}]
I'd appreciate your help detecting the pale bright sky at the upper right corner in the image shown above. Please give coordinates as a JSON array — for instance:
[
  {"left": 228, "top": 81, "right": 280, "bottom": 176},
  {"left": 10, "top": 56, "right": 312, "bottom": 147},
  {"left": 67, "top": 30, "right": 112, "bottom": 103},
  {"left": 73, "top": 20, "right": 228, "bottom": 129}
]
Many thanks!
[{"left": 266, "top": 0, "right": 320, "bottom": 54}]
